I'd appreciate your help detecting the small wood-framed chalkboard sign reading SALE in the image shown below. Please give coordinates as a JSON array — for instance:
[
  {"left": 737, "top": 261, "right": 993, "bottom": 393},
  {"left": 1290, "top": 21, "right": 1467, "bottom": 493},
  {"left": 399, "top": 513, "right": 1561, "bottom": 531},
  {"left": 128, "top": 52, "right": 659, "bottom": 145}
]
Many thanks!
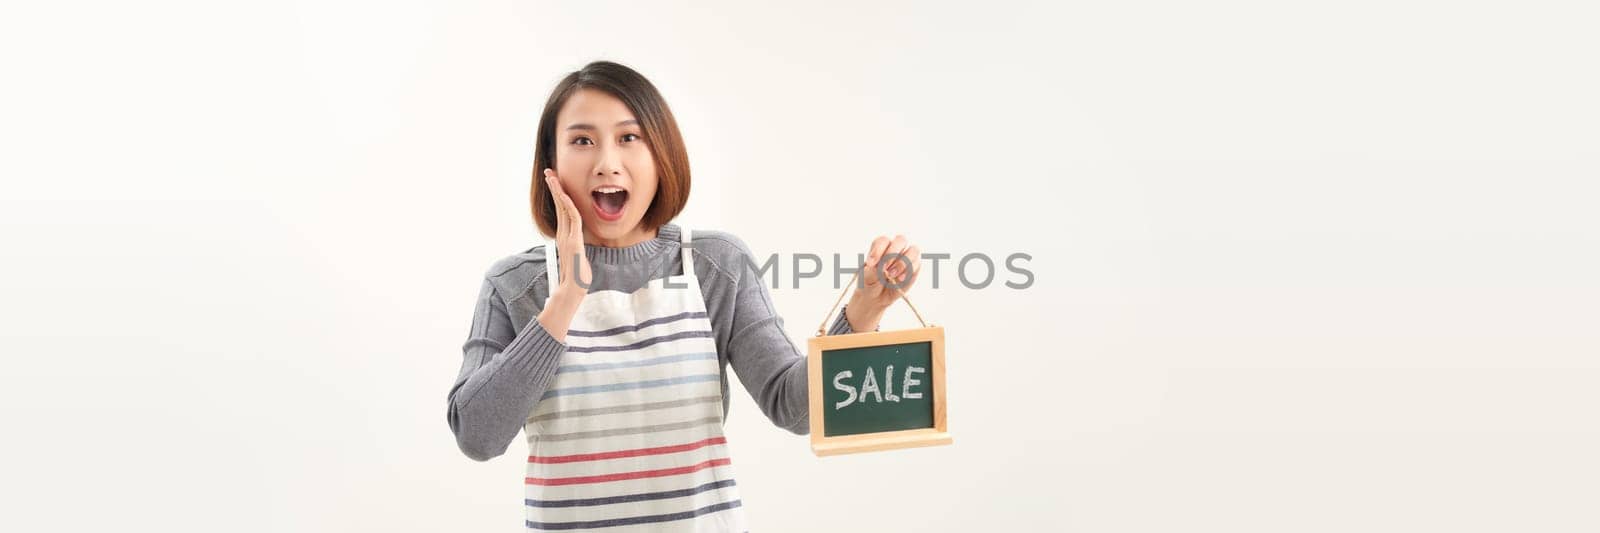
[{"left": 806, "top": 327, "right": 952, "bottom": 456}]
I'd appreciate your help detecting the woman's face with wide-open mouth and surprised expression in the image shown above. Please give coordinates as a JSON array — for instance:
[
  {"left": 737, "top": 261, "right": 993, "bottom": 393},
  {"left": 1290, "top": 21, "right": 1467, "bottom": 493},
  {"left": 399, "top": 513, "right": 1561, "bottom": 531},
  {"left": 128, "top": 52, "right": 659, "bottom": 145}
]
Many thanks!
[{"left": 555, "top": 90, "right": 656, "bottom": 246}]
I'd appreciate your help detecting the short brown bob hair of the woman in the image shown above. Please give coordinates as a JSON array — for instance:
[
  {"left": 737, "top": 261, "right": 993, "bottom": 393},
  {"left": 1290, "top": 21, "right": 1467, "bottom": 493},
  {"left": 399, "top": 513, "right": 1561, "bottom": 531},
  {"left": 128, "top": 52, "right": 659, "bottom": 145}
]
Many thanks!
[{"left": 528, "top": 61, "right": 690, "bottom": 237}]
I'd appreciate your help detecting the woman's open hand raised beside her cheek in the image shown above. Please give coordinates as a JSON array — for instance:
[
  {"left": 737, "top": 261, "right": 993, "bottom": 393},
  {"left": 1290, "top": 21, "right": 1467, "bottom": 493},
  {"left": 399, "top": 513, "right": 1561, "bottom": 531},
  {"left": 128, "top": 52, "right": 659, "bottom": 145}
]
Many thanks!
[{"left": 539, "top": 168, "right": 594, "bottom": 343}]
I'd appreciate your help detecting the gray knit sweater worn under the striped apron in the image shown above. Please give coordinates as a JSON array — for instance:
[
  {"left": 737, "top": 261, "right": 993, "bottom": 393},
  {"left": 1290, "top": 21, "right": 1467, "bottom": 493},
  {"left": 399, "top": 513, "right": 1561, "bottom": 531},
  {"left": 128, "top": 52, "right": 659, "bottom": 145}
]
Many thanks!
[{"left": 448, "top": 224, "right": 850, "bottom": 461}]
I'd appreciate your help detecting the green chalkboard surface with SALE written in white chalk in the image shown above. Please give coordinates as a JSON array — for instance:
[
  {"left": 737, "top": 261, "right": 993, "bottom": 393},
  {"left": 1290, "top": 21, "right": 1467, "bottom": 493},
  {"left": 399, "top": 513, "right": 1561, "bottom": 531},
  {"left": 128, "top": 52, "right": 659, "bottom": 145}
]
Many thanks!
[{"left": 822, "top": 343, "right": 934, "bottom": 437}]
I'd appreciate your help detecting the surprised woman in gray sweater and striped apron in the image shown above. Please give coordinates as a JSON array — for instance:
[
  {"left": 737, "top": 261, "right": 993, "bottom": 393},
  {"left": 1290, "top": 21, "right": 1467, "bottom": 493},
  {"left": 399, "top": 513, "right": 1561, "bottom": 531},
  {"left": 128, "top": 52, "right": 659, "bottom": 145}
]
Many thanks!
[{"left": 448, "top": 61, "right": 918, "bottom": 531}]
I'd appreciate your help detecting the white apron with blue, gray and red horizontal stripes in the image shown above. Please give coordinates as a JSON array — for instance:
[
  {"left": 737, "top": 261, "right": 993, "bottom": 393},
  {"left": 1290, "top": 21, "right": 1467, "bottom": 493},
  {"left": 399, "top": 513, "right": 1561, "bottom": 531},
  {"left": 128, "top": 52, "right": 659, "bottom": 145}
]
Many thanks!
[{"left": 523, "top": 227, "right": 746, "bottom": 531}]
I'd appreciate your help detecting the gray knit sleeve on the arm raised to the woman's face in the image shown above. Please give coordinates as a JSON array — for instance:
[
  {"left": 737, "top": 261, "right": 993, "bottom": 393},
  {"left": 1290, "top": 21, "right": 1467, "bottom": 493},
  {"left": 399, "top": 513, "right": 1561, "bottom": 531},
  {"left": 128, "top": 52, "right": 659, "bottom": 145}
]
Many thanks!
[{"left": 448, "top": 279, "right": 566, "bottom": 461}]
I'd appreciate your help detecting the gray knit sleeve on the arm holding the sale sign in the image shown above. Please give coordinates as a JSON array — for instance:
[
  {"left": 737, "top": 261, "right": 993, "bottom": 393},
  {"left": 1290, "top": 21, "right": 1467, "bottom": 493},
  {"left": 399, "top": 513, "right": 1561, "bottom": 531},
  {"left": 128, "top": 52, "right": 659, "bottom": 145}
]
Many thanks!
[{"left": 707, "top": 232, "right": 851, "bottom": 435}]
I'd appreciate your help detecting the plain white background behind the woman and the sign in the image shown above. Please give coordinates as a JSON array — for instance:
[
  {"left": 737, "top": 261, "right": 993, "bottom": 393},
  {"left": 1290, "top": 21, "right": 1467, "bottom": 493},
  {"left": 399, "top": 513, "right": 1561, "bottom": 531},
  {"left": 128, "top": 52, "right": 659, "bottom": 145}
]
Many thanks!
[{"left": 0, "top": 2, "right": 1600, "bottom": 531}]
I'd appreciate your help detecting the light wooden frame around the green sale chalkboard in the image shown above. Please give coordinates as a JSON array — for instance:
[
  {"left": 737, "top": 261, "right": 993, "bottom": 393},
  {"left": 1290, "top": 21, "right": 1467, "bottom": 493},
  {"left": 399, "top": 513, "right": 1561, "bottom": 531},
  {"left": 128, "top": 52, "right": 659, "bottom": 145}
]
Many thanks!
[{"left": 806, "top": 327, "right": 954, "bottom": 456}]
